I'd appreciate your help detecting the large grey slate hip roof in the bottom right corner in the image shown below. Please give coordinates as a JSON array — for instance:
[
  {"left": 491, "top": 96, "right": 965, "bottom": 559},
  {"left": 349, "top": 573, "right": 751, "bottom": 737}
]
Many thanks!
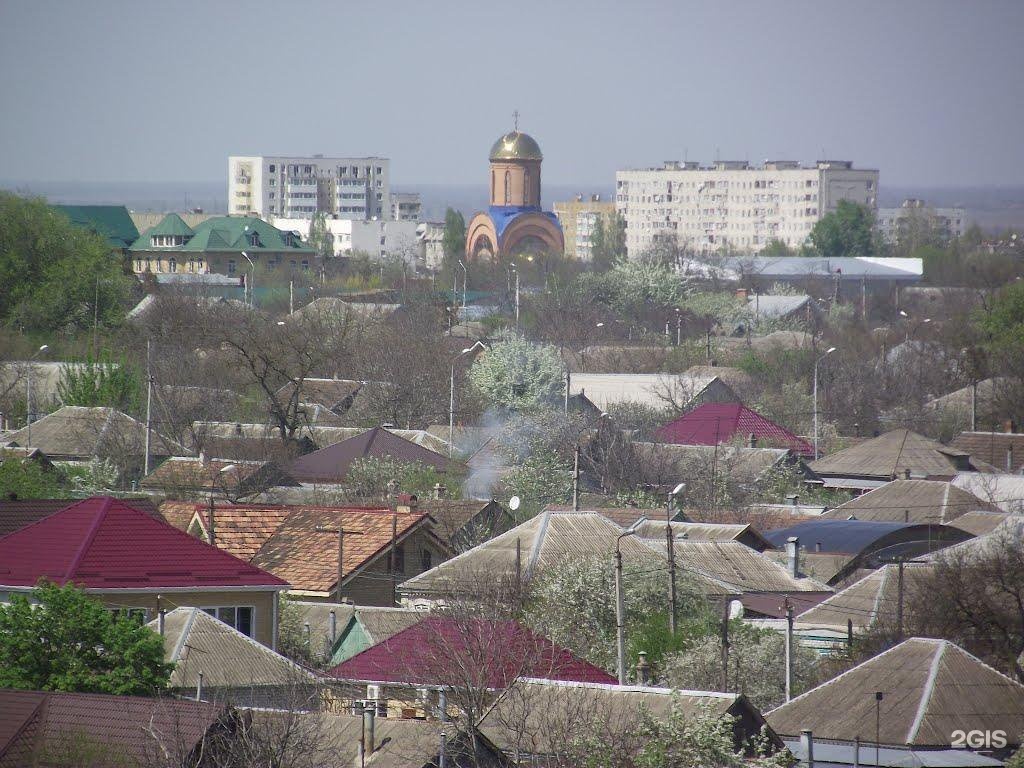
[{"left": 766, "top": 637, "right": 1024, "bottom": 746}]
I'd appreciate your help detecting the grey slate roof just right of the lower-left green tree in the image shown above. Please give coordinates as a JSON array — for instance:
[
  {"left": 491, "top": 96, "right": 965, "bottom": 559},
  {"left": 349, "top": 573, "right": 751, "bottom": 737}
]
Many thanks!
[{"left": 147, "top": 607, "right": 316, "bottom": 689}]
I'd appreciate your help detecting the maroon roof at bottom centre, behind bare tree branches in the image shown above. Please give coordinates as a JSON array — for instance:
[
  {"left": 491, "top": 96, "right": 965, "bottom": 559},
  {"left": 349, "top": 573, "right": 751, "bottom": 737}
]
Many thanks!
[{"left": 329, "top": 616, "right": 615, "bottom": 688}]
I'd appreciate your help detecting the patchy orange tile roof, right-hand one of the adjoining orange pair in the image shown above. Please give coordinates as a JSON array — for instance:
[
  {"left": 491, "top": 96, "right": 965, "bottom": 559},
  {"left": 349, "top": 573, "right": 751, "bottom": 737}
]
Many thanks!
[{"left": 252, "top": 507, "right": 430, "bottom": 592}]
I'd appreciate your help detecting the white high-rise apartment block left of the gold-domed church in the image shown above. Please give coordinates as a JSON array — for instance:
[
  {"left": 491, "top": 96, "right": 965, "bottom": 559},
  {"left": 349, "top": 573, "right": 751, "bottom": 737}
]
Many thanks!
[{"left": 227, "top": 155, "right": 391, "bottom": 219}]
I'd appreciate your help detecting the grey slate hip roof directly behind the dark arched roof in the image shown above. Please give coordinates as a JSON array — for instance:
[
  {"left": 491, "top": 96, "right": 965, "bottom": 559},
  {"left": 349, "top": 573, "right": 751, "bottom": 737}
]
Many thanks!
[{"left": 821, "top": 480, "right": 995, "bottom": 524}]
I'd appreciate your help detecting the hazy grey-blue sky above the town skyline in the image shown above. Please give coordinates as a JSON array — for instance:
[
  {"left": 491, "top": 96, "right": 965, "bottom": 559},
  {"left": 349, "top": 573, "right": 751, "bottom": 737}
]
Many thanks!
[{"left": 0, "top": 0, "right": 1024, "bottom": 185}]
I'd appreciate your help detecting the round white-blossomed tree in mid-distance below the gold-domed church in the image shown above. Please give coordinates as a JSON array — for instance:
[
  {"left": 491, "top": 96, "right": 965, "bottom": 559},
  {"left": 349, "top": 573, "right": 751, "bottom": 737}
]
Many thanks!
[{"left": 469, "top": 334, "right": 565, "bottom": 411}]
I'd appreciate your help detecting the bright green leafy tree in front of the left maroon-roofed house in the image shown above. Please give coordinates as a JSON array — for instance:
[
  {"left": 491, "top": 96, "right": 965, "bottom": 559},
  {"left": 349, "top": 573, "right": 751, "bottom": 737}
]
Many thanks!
[{"left": 0, "top": 582, "right": 172, "bottom": 695}]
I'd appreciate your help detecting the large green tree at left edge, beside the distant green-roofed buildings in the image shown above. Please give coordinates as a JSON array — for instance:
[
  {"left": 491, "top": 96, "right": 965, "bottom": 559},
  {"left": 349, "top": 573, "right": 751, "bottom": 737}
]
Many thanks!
[{"left": 0, "top": 193, "right": 134, "bottom": 331}]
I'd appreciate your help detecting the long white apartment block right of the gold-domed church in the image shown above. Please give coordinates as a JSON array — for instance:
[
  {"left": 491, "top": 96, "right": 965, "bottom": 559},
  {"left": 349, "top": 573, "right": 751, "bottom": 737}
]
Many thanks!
[{"left": 615, "top": 160, "right": 879, "bottom": 256}]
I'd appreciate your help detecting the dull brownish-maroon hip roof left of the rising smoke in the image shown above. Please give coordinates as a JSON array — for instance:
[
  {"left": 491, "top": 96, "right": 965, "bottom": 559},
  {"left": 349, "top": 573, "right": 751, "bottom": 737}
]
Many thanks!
[{"left": 288, "top": 427, "right": 452, "bottom": 482}]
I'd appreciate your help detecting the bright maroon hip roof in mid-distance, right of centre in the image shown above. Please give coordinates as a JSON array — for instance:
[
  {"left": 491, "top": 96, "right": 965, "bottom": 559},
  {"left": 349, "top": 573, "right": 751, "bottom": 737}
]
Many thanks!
[{"left": 655, "top": 402, "right": 814, "bottom": 457}]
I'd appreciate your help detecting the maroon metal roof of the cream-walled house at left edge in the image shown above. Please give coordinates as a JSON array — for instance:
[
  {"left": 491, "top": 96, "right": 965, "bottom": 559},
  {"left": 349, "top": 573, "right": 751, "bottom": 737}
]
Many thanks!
[{"left": 0, "top": 497, "right": 288, "bottom": 589}]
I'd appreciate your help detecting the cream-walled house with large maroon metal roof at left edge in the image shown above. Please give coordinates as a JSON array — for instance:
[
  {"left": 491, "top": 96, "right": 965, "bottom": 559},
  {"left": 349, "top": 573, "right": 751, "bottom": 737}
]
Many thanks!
[{"left": 0, "top": 497, "right": 288, "bottom": 646}]
